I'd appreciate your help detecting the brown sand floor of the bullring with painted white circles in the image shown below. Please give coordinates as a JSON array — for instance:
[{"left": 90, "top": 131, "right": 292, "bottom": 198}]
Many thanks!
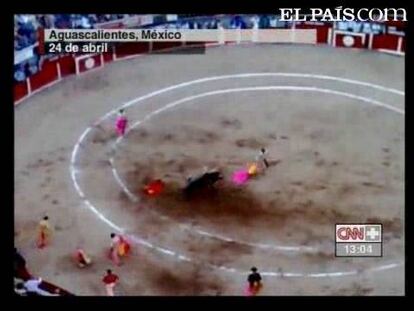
[{"left": 15, "top": 15, "right": 405, "bottom": 296}]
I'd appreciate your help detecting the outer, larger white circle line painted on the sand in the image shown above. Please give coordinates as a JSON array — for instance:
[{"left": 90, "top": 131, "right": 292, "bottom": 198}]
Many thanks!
[{"left": 69, "top": 73, "right": 404, "bottom": 277}]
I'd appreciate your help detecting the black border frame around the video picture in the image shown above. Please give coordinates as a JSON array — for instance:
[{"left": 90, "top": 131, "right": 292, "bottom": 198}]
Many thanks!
[{"left": 4, "top": 0, "right": 414, "bottom": 309}]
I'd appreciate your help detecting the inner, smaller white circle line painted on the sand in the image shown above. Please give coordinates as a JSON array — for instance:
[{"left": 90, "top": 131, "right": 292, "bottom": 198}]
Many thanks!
[{"left": 109, "top": 86, "right": 404, "bottom": 252}]
